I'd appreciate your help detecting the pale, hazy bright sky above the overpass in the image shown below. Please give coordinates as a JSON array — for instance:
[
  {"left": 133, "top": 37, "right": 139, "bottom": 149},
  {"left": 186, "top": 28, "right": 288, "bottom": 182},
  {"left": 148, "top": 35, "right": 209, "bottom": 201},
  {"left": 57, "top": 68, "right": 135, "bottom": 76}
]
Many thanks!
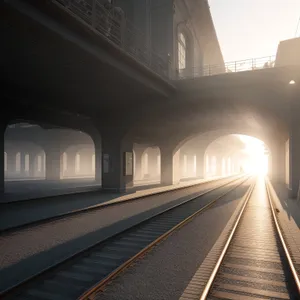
[{"left": 209, "top": 0, "right": 300, "bottom": 62}]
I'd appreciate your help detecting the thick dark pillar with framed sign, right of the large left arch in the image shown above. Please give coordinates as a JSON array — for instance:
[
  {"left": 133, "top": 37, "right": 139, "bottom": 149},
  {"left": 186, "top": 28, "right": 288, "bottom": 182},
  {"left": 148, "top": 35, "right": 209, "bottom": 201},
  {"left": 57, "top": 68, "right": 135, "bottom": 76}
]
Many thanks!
[{"left": 102, "top": 131, "right": 133, "bottom": 192}]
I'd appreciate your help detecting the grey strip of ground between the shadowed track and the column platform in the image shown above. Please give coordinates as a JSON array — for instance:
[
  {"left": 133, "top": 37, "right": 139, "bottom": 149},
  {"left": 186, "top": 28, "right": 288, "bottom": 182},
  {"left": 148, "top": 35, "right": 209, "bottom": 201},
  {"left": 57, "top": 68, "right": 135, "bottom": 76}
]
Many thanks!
[{"left": 0, "top": 178, "right": 233, "bottom": 290}]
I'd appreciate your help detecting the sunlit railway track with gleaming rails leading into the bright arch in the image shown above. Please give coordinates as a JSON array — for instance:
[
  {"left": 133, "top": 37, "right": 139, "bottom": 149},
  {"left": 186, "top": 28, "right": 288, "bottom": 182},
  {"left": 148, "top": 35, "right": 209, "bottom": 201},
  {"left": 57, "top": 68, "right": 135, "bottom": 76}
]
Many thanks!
[{"left": 197, "top": 177, "right": 300, "bottom": 300}]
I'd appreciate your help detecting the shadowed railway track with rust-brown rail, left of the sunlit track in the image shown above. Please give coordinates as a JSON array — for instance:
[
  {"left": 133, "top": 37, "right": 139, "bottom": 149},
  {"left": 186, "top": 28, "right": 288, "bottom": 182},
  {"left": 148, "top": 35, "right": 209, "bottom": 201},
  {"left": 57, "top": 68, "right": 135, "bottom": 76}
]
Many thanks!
[{"left": 0, "top": 176, "right": 250, "bottom": 300}]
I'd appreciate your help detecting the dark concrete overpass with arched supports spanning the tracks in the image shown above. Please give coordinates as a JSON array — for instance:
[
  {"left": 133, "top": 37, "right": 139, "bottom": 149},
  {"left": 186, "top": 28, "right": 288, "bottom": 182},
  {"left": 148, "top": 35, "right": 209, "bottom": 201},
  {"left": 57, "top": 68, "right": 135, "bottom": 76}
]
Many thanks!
[{"left": 1, "top": 0, "right": 300, "bottom": 195}]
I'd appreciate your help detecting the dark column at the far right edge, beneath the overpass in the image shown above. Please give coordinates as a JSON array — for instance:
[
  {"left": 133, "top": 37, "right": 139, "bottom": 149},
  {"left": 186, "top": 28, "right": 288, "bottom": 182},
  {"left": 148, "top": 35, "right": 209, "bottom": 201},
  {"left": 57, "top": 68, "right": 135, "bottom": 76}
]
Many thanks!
[{"left": 289, "top": 84, "right": 300, "bottom": 198}]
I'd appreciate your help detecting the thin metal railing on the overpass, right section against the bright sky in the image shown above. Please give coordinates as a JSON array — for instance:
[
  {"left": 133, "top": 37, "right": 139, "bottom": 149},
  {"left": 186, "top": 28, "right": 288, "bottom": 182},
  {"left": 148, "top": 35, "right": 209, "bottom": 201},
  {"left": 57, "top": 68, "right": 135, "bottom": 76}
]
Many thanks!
[{"left": 175, "top": 56, "right": 275, "bottom": 80}]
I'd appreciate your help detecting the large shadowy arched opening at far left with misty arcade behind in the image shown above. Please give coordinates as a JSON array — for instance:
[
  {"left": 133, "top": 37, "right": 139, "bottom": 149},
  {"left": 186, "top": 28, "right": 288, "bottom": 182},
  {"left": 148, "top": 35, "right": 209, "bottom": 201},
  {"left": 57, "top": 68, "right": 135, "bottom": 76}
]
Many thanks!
[{"left": 4, "top": 122, "right": 97, "bottom": 200}]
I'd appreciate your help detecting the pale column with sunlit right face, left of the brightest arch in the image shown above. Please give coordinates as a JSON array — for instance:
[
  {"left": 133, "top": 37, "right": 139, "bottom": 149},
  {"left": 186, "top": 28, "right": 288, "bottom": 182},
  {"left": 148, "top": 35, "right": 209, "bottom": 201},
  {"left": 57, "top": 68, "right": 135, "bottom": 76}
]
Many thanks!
[{"left": 160, "top": 147, "right": 180, "bottom": 185}]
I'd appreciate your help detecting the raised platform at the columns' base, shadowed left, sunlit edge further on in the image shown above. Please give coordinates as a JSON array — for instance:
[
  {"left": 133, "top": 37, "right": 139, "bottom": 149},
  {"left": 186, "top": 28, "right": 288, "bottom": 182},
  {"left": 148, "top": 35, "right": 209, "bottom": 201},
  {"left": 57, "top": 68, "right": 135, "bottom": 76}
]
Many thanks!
[{"left": 0, "top": 177, "right": 218, "bottom": 231}]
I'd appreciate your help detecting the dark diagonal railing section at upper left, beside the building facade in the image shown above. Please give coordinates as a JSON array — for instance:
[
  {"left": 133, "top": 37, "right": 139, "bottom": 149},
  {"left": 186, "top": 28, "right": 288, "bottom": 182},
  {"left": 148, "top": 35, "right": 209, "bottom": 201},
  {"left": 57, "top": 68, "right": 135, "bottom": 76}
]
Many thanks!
[{"left": 52, "top": 0, "right": 169, "bottom": 79}]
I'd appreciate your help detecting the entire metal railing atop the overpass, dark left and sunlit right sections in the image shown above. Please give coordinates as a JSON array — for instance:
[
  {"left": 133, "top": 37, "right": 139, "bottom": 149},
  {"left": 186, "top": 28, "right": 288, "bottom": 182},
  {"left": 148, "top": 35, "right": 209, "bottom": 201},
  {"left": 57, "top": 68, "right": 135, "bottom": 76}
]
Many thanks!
[{"left": 52, "top": 0, "right": 275, "bottom": 80}]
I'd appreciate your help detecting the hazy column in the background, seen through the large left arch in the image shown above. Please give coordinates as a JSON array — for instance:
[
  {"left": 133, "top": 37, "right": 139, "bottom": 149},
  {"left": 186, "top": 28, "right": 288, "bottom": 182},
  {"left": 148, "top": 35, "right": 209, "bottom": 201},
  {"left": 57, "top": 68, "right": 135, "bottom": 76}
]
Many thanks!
[{"left": 45, "top": 146, "right": 62, "bottom": 180}]
